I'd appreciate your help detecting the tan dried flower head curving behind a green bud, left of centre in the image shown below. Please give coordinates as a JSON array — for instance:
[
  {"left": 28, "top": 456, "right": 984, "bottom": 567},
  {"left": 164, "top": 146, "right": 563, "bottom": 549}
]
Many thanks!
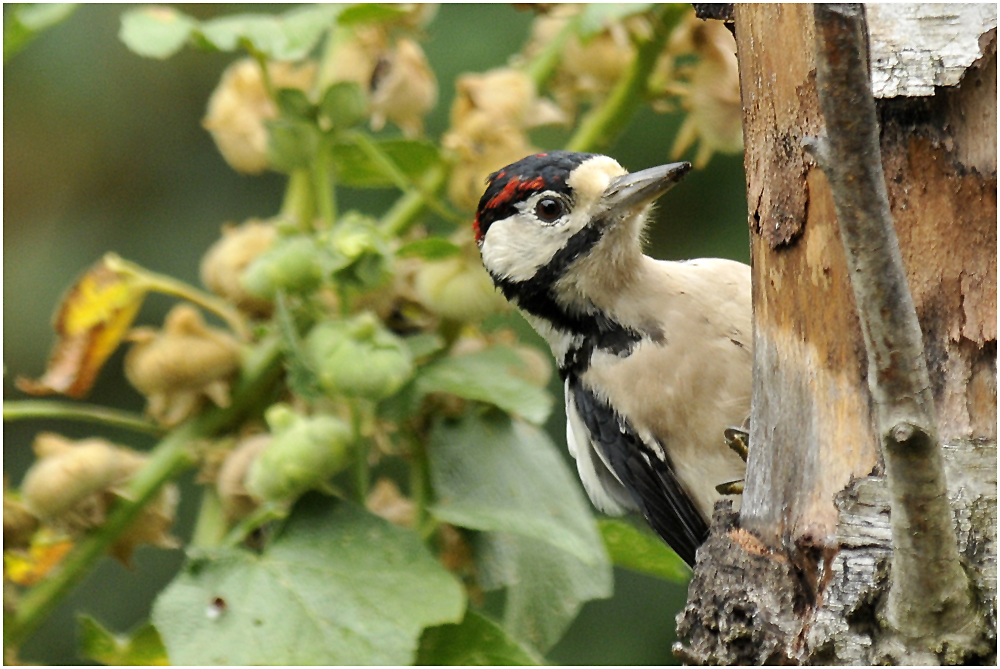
[{"left": 201, "top": 219, "right": 278, "bottom": 316}]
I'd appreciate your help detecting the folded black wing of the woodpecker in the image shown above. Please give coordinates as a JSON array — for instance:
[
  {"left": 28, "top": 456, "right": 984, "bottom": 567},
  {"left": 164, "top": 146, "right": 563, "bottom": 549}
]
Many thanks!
[{"left": 569, "top": 379, "right": 708, "bottom": 566}]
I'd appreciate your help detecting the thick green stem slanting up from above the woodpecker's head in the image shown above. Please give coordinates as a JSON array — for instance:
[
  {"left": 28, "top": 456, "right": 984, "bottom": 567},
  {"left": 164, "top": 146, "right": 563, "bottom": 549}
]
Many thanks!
[{"left": 566, "top": 5, "right": 682, "bottom": 151}]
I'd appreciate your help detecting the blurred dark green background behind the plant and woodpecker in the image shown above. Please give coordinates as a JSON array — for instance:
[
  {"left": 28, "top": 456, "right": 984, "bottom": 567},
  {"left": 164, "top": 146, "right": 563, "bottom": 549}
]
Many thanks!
[{"left": 3, "top": 5, "right": 749, "bottom": 664}]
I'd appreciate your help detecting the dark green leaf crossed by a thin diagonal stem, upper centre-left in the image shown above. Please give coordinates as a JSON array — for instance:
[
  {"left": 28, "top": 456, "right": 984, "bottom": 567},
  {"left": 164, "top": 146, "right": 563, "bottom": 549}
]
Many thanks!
[{"left": 332, "top": 139, "right": 441, "bottom": 188}]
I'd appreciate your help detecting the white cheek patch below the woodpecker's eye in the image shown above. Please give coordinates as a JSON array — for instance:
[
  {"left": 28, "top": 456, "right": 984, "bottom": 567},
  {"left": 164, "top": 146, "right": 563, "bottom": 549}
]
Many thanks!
[{"left": 480, "top": 216, "right": 575, "bottom": 281}]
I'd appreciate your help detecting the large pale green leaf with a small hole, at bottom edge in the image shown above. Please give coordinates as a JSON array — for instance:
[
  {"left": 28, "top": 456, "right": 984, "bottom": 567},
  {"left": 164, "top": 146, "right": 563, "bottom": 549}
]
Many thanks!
[{"left": 153, "top": 494, "right": 465, "bottom": 665}]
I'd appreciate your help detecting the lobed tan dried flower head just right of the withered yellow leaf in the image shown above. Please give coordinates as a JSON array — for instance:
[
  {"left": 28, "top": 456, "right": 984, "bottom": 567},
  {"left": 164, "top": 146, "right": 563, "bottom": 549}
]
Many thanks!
[{"left": 125, "top": 304, "right": 240, "bottom": 425}]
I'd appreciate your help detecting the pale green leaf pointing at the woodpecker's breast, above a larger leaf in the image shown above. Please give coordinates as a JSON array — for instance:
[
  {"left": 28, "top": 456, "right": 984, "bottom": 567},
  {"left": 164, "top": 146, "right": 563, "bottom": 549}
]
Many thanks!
[{"left": 417, "top": 346, "right": 553, "bottom": 424}]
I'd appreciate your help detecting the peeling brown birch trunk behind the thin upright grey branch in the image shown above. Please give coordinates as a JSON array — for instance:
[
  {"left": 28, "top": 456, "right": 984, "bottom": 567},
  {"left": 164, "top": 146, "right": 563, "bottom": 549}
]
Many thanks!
[{"left": 676, "top": 5, "right": 997, "bottom": 664}]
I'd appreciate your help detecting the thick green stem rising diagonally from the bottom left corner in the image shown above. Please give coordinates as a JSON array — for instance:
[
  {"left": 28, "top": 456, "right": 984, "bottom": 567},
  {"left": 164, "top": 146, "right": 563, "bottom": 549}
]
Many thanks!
[{"left": 4, "top": 341, "right": 281, "bottom": 648}]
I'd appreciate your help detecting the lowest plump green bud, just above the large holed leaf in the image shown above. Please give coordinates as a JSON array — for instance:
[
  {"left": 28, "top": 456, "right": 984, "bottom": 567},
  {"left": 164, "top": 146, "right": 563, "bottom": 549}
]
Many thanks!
[{"left": 244, "top": 405, "right": 354, "bottom": 501}]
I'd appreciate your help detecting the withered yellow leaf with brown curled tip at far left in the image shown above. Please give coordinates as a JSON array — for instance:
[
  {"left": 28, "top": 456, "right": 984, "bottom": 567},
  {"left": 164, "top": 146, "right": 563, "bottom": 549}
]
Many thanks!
[{"left": 17, "top": 258, "right": 147, "bottom": 398}]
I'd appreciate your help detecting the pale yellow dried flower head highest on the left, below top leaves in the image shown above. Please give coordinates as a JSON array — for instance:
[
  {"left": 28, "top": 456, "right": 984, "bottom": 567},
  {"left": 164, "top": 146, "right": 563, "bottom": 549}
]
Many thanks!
[{"left": 208, "top": 58, "right": 316, "bottom": 174}]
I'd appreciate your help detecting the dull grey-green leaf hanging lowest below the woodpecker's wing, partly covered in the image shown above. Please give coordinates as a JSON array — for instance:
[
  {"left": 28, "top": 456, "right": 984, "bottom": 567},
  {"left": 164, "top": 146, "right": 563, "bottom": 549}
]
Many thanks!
[{"left": 476, "top": 532, "right": 614, "bottom": 653}]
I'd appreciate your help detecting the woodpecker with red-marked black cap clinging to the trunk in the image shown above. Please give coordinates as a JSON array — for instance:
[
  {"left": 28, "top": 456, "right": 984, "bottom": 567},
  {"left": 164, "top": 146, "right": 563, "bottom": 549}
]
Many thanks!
[{"left": 475, "top": 151, "right": 752, "bottom": 564}]
